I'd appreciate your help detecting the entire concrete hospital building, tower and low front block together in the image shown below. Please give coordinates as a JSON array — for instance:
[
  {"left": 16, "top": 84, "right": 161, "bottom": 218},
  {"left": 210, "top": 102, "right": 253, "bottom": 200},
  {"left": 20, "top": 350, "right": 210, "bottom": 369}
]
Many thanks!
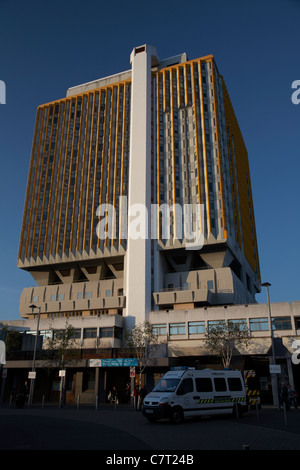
[{"left": 8, "top": 45, "right": 300, "bottom": 402}]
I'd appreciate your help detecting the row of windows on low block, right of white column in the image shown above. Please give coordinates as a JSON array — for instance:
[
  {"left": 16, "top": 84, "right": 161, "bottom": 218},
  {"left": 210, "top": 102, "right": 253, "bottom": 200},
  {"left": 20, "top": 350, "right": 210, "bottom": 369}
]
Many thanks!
[{"left": 152, "top": 317, "right": 292, "bottom": 335}]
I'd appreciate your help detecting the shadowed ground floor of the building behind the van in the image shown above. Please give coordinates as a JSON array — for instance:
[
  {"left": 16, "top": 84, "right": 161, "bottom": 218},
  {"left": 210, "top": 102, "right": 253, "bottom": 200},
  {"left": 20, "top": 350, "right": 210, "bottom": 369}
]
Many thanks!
[{"left": 0, "top": 355, "right": 300, "bottom": 405}]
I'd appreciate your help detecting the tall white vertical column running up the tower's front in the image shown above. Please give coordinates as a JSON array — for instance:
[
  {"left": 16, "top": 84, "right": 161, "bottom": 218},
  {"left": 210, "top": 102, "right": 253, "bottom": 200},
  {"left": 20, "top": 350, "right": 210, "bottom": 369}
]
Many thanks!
[{"left": 125, "top": 45, "right": 157, "bottom": 328}]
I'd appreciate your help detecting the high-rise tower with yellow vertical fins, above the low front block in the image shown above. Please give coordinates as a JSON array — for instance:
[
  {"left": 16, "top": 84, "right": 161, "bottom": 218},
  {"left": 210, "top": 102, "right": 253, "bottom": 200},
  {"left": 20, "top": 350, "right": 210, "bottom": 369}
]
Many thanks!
[{"left": 17, "top": 45, "right": 260, "bottom": 321}]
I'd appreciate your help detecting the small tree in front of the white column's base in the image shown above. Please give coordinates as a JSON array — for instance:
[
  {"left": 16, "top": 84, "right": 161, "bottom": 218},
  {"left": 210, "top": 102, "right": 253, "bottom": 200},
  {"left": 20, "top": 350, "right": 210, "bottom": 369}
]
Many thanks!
[{"left": 125, "top": 321, "right": 158, "bottom": 392}]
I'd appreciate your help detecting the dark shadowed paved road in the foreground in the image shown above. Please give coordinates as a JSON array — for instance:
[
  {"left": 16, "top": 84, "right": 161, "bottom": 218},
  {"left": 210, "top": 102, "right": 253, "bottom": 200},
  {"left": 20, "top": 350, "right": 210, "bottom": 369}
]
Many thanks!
[{"left": 0, "top": 406, "right": 300, "bottom": 453}]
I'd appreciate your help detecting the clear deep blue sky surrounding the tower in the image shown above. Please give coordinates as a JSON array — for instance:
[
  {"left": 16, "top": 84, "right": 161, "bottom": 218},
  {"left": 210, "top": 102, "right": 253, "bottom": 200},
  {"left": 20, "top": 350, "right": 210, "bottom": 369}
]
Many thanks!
[{"left": 0, "top": 0, "right": 300, "bottom": 321}]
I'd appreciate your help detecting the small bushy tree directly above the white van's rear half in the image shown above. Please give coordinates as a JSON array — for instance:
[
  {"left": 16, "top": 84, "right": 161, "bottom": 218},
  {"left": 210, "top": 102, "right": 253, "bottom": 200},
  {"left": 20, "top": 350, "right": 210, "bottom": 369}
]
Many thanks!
[{"left": 205, "top": 320, "right": 251, "bottom": 368}]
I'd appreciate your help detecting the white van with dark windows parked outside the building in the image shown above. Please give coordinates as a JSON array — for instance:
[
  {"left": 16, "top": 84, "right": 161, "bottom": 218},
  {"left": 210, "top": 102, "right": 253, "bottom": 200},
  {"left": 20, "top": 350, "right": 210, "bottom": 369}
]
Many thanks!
[{"left": 143, "top": 368, "right": 248, "bottom": 423}]
